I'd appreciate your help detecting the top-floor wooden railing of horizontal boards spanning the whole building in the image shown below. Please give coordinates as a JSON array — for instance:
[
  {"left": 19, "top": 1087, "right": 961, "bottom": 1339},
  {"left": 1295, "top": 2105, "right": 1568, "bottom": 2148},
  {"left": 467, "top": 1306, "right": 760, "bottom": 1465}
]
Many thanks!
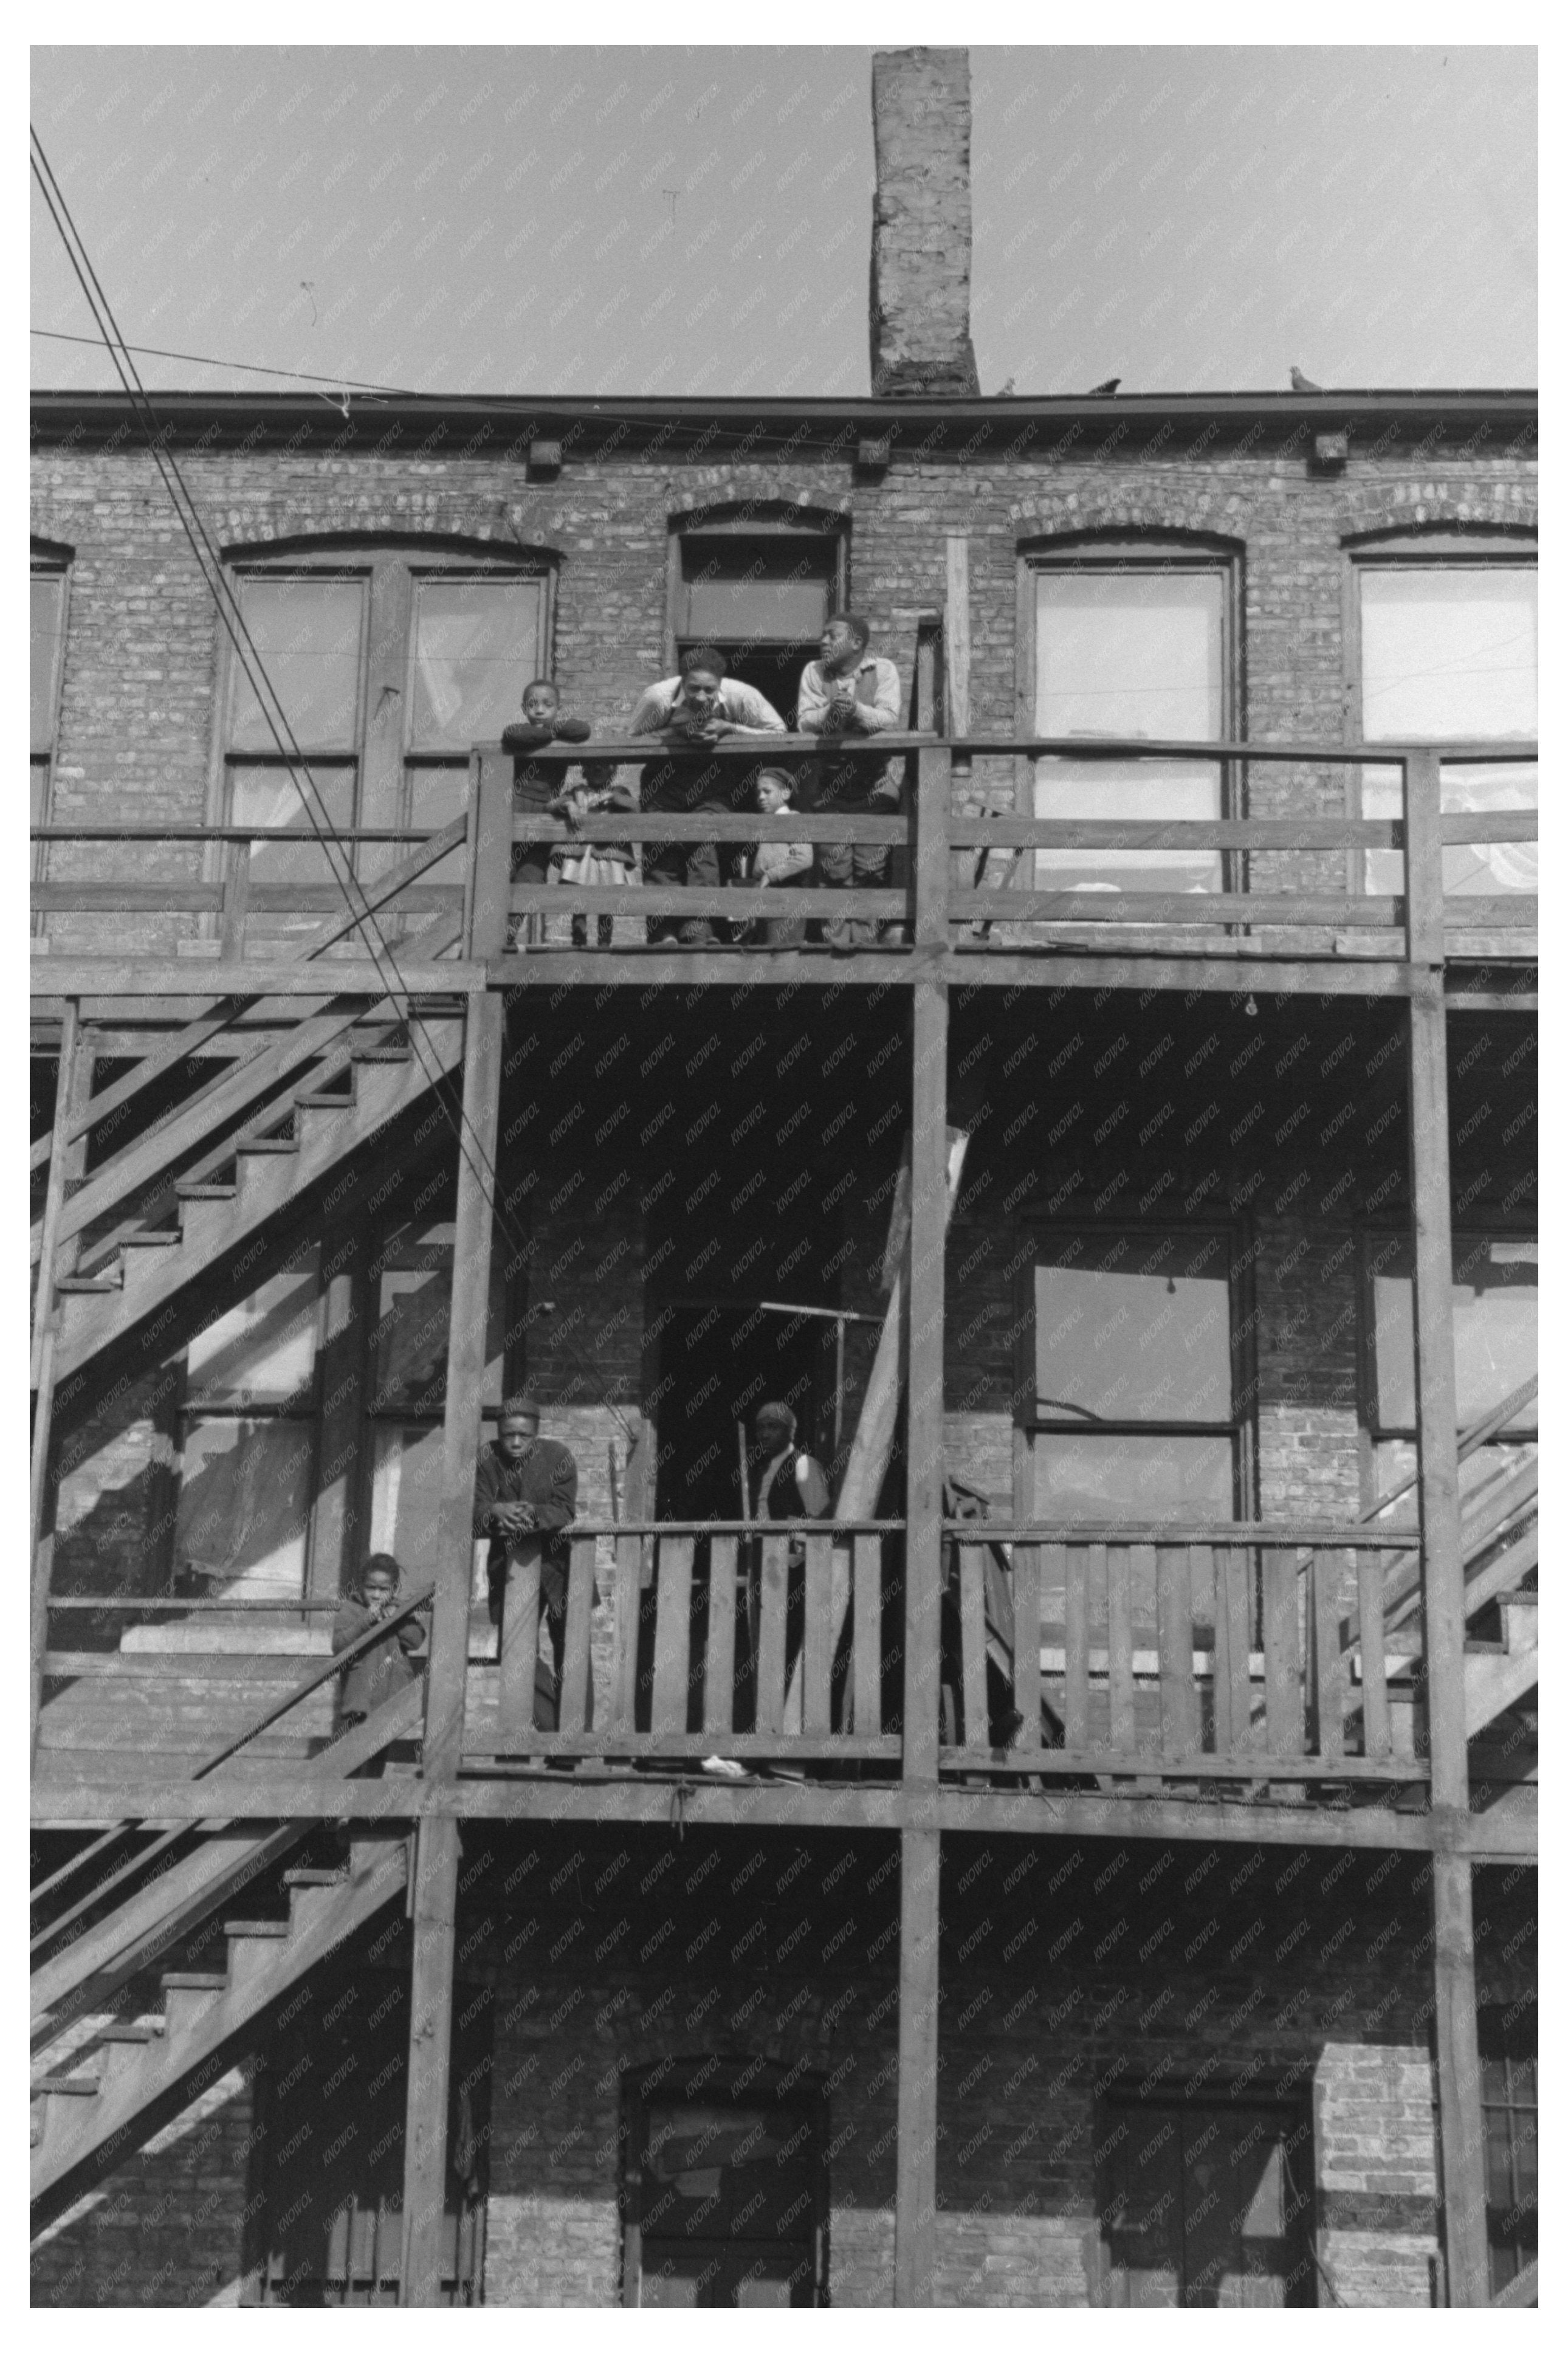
[{"left": 33, "top": 734, "right": 1538, "bottom": 962}]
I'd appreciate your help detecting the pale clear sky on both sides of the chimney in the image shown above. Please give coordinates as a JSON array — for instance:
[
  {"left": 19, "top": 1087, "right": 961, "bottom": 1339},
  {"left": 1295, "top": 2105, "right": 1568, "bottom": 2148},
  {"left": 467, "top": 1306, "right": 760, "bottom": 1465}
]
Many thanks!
[{"left": 30, "top": 45, "right": 1538, "bottom": 398}]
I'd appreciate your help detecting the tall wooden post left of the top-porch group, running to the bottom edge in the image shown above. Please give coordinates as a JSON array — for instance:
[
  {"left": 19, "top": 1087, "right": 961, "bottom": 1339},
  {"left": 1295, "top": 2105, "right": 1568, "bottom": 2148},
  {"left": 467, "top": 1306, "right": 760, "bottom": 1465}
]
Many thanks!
[{"left": 401, "top": 757, "right": 511, "bottom": 2306}]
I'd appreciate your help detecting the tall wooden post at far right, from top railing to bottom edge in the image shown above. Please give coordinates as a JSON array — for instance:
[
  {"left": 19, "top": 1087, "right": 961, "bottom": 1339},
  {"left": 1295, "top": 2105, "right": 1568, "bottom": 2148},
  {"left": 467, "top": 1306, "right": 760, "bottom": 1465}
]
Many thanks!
[{"left": 1406, "top": 753, "right": 1488, "bottom": 2306}]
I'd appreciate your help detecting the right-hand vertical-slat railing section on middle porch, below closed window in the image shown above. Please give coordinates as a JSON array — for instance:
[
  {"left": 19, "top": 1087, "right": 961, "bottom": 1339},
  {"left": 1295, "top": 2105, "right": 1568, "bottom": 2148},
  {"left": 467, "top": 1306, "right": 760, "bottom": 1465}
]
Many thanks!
[{"left": 944, "top": 1523, "right": 1427, "bottom": 1786}]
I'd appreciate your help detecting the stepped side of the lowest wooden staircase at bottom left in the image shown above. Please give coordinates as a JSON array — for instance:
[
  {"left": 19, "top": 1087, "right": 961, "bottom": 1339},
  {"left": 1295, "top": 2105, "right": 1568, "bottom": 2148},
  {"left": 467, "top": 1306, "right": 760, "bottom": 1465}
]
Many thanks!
[{"left": 30, "top": 1833, "right": 407, "bottom": 2228}]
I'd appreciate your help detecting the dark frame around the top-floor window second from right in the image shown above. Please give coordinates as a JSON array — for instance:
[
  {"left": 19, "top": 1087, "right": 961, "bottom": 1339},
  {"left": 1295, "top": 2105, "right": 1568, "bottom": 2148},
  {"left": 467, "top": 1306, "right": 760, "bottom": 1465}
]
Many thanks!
[{"left": 1013, "top": 529, "right": 1248, "bottom": 894}]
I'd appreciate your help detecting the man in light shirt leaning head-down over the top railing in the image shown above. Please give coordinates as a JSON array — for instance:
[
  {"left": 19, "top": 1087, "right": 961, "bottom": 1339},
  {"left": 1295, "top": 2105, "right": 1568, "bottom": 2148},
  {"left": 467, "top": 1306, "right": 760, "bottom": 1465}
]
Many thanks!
[{"left": 631, "top": 645, "right": 784, "bottom": 948}]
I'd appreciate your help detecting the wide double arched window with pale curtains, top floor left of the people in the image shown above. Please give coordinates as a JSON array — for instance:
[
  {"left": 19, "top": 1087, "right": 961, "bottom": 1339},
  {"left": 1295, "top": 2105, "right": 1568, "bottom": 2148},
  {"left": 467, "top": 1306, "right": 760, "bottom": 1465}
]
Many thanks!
[{"left": 215, "top": 539, "right": 549, "bottom": 937}]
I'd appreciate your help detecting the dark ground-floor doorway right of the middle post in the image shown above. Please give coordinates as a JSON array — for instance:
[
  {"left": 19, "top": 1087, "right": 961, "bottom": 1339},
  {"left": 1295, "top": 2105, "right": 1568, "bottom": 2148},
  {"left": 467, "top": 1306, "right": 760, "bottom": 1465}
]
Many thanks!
[{"left": 1099, "top": 2099, "right": 1316, "bottom": 2310}]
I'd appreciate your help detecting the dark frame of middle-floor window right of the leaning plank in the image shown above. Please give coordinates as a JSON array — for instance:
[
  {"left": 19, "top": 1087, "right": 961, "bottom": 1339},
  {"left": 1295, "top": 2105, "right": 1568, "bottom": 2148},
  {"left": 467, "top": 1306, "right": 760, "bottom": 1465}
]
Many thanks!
[{"left": 1013, "top": 1212, "right": 1257, "bottom": 1534}]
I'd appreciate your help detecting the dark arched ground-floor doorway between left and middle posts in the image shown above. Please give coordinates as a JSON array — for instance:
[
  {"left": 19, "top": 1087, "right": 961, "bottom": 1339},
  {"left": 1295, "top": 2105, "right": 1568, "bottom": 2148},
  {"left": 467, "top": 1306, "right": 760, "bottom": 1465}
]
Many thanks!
[{"left": 622, "top": 2059, "right": 829, "bottom": 2310}]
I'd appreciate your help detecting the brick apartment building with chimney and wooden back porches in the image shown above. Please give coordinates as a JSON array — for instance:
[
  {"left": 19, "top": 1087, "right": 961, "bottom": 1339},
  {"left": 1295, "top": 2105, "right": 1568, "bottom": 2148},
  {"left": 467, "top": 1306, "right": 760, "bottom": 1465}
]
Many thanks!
[{"left": 33, "top": 52, "right": 1538, "bottom": 2306}]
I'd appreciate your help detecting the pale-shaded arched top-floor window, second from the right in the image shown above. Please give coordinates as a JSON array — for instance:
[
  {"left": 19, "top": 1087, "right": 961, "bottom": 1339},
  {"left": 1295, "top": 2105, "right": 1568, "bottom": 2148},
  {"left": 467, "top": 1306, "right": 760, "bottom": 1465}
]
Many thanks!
[{"left": 1019, "top": 534, "right": 1241, "bottom": 892}]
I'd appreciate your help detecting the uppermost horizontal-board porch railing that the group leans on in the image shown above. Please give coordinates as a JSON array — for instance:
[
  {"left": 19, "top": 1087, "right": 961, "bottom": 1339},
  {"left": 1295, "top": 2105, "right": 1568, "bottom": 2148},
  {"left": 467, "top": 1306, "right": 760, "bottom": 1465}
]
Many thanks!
[{"left": 35, "top": 732, "right": 1538, "bottom": 960}]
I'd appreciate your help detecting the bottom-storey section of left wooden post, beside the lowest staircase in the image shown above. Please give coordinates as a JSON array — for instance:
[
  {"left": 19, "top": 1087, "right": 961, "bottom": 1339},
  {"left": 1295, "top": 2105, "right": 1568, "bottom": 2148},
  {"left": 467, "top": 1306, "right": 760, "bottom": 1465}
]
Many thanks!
[{"left": 398, "top": 1816, "right": 459, "bottom": 2306}]
